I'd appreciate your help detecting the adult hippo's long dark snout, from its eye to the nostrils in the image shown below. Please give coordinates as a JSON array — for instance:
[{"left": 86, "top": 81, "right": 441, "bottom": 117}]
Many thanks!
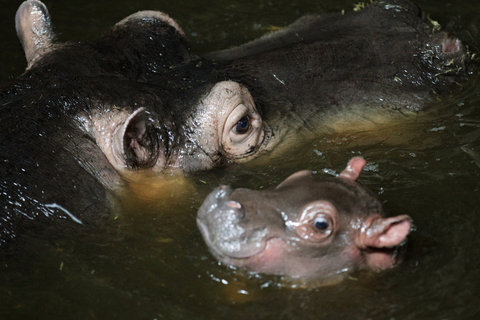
[{"left": 213, "top": 0, "right": 471, "bottom": 141}]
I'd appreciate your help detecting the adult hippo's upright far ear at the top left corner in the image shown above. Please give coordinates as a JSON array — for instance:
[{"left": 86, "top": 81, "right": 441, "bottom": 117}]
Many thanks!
[{"left": 15, "top": 0, "right": 54, "bottom": 68}]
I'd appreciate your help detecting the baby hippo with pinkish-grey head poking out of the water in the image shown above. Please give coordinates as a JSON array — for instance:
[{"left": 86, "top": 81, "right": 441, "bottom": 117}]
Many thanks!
[{"left": 197, "top": 157, "right": 411, "bottom": 281}]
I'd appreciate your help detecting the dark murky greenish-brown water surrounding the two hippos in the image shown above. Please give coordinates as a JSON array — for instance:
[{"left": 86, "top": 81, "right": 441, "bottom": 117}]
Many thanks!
[{"left": 0, "top": 0, "right": 480, "bottom": 319}]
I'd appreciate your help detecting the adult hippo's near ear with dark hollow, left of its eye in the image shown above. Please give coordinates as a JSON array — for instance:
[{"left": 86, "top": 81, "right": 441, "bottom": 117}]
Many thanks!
[{"left": 112, "top": 108, "right": 159, "bottom": 168}]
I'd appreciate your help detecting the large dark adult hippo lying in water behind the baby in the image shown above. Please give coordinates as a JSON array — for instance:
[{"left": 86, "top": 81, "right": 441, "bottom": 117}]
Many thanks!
[{"left": 0, "top": 0, "right": 470, "bottom": 248}]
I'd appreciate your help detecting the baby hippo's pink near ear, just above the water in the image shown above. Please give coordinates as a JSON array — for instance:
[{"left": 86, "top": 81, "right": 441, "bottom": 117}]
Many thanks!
[{"left": 357, "top": 215, "right": 411, "bottom": 248}]
